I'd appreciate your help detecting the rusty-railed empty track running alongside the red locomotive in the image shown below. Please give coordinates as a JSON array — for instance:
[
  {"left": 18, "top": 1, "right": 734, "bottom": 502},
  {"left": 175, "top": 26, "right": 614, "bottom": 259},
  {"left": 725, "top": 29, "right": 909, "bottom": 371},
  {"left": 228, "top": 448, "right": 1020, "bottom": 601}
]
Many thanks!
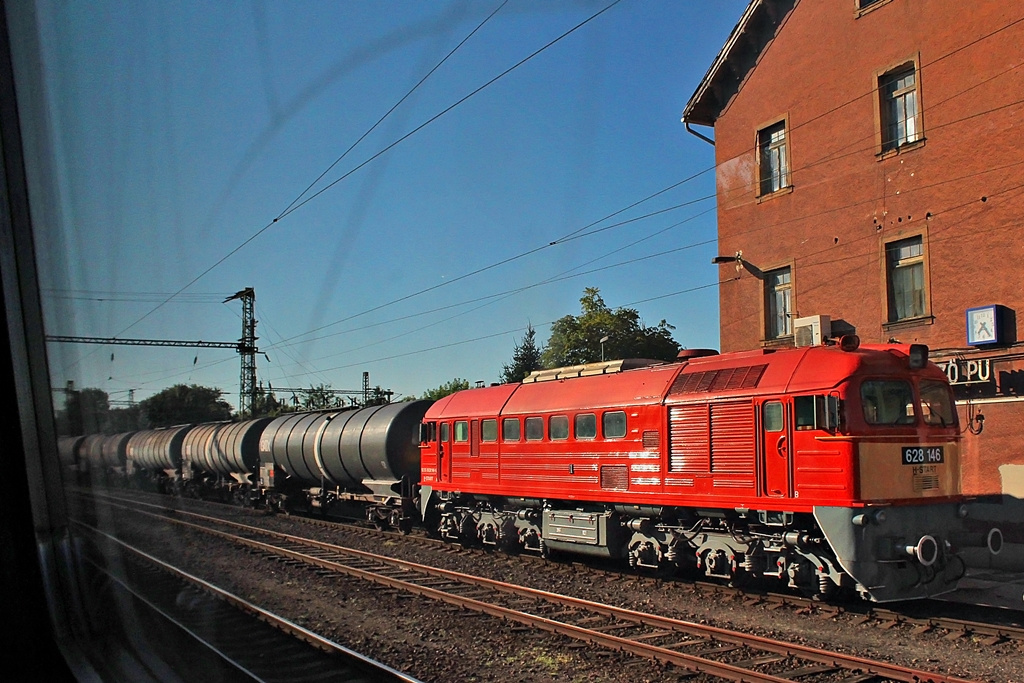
[{"left": 75, "top": 493, "right": 987, "bottom": 683}]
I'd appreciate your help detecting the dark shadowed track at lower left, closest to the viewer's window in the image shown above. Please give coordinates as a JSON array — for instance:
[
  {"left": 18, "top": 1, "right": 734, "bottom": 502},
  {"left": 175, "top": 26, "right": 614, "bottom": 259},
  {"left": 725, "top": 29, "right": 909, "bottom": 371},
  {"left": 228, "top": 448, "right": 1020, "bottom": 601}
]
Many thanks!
[{"left": 74, "top": 521, "right": 419, "bottom": 683}]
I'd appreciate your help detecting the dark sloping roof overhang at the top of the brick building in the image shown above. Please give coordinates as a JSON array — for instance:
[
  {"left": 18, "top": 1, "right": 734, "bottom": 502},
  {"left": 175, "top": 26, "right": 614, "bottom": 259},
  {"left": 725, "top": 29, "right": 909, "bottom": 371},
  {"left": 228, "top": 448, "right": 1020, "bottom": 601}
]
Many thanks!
[{"left": 682, "top": 0, "right": 800, "bottom": 126}]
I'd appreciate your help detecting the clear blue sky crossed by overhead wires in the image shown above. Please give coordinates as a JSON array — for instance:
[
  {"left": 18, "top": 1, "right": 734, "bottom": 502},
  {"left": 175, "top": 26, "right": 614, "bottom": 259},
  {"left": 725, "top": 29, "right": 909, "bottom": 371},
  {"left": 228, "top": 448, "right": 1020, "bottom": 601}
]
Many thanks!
[{"left": 32, "top": 0, "right": 746, "bottom": 405}]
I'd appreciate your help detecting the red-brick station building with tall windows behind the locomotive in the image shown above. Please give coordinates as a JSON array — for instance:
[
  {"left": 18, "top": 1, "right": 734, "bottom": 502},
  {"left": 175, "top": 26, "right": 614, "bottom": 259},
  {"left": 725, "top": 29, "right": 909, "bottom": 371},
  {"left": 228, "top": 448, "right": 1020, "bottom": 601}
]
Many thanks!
[{"left": 683, "top": 0, "right": 1024, "bottom": 498}]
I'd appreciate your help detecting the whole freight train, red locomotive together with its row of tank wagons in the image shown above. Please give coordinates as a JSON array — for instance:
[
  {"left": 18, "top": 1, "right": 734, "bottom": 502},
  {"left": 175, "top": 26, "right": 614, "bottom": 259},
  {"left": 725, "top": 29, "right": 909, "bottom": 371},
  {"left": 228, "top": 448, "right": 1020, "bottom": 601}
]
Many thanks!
[{"left": 61, "top": 336, "right": 1001, "bottom": 602}]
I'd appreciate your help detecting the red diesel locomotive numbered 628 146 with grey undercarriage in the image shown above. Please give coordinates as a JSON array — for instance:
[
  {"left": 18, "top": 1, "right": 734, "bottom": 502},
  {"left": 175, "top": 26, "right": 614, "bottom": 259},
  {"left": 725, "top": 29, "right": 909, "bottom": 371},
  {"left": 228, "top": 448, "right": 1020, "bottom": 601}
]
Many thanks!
[{"left": 420, "top": 337, "right": 1001, "bottom": 601}]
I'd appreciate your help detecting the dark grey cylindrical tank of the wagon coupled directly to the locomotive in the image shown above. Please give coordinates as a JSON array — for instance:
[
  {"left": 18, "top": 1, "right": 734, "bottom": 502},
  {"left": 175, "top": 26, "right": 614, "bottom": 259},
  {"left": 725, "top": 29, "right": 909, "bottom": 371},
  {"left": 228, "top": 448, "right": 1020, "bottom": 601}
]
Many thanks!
[{"left": 260, "top": 400, "right": 431, "bottom": 494}]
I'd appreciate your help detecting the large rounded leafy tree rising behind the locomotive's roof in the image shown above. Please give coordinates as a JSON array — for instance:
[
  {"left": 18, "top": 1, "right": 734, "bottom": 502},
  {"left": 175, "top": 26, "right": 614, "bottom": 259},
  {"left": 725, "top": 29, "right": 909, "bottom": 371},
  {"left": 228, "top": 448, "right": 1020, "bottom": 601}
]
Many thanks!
[{"left": 541, "top": 287, "right": 679, "bottom": 368}]
